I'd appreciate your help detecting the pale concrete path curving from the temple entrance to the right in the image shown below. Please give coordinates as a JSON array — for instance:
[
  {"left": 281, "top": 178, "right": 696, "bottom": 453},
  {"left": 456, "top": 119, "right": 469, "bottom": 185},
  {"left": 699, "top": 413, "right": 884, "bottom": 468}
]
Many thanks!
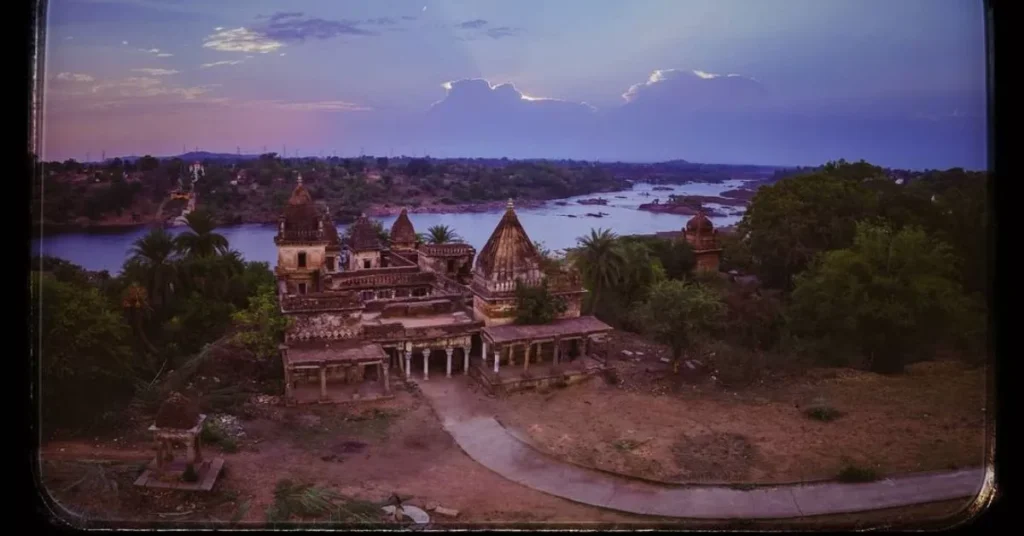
[{"left": 417, "top": 378, "right": 985, "bottom": 520}]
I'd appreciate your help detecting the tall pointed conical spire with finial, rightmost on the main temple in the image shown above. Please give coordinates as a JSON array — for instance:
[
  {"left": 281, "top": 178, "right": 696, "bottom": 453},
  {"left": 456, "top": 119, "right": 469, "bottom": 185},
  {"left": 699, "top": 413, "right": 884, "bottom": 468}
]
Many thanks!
[{"left": 476, "top": 199, "right": 541, "bottom": 280}]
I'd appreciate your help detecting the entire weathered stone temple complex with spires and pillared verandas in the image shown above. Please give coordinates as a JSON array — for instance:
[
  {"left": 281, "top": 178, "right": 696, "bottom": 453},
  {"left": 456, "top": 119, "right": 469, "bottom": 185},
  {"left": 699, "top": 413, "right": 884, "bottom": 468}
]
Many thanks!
[{"left": 274, "top": 176, "right": 611, "bottom": 403}]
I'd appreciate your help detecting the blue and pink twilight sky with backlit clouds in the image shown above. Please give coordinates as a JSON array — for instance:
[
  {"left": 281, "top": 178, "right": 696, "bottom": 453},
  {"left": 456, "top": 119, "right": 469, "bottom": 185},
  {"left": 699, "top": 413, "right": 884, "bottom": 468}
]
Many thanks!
[{"left": 38, "top": 0, "right": 987, "bottom": 169}]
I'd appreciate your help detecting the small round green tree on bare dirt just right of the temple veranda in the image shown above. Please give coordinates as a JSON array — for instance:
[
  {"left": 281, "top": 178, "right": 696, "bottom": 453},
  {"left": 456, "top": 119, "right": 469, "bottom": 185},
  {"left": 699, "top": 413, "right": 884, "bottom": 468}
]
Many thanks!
[{"left": 634, "top": 280, "right": 725, "bottom": 372}]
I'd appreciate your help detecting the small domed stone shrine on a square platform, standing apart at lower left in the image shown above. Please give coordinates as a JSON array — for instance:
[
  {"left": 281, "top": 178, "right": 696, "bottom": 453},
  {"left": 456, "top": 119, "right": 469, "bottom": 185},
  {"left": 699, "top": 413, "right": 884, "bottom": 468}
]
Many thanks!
[{"left": 135, "top": 393, "right": 224, "bottom": 491}]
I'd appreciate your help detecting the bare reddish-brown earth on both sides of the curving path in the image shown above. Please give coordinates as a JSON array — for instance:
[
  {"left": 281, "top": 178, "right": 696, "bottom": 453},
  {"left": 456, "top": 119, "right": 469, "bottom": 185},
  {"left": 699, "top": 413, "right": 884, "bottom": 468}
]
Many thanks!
[{"left": 41, "top": 332, "right": 984, "bottom": 528}]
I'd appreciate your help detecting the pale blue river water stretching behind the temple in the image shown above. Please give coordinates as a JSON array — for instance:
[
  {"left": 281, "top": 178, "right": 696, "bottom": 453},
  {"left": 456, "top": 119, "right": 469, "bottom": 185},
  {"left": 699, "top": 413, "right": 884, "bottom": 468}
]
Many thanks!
[{"left": 32, "top": 179, "right": 744, "bottom": 274}]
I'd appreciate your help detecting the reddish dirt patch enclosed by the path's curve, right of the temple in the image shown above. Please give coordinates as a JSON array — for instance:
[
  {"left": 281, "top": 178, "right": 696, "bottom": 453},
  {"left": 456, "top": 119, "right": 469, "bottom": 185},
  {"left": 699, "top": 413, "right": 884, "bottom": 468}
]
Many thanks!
[{"left": 496, "top": 334, "right": 986, "bottom": 483}]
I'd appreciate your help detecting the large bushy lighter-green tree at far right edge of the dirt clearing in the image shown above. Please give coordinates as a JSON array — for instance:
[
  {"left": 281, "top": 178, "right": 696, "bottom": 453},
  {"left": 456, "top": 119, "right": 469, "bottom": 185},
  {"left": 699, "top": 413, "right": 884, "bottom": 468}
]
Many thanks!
[{"left": 788, "top": 222, "right": 970, "bottom": 372}]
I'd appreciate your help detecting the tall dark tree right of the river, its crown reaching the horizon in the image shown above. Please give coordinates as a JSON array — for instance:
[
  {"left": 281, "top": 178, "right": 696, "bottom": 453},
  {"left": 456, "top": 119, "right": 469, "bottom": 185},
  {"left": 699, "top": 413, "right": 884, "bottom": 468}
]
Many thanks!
[{"left": 738, "top": 173, "right": 876, "bottom": 288}]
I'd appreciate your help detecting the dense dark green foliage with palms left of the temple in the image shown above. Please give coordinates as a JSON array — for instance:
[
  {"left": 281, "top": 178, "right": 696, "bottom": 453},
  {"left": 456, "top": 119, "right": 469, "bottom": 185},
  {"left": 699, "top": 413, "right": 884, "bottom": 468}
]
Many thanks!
[{"left": 31, "top": 212, "right": 287, "bottom": 429}]
